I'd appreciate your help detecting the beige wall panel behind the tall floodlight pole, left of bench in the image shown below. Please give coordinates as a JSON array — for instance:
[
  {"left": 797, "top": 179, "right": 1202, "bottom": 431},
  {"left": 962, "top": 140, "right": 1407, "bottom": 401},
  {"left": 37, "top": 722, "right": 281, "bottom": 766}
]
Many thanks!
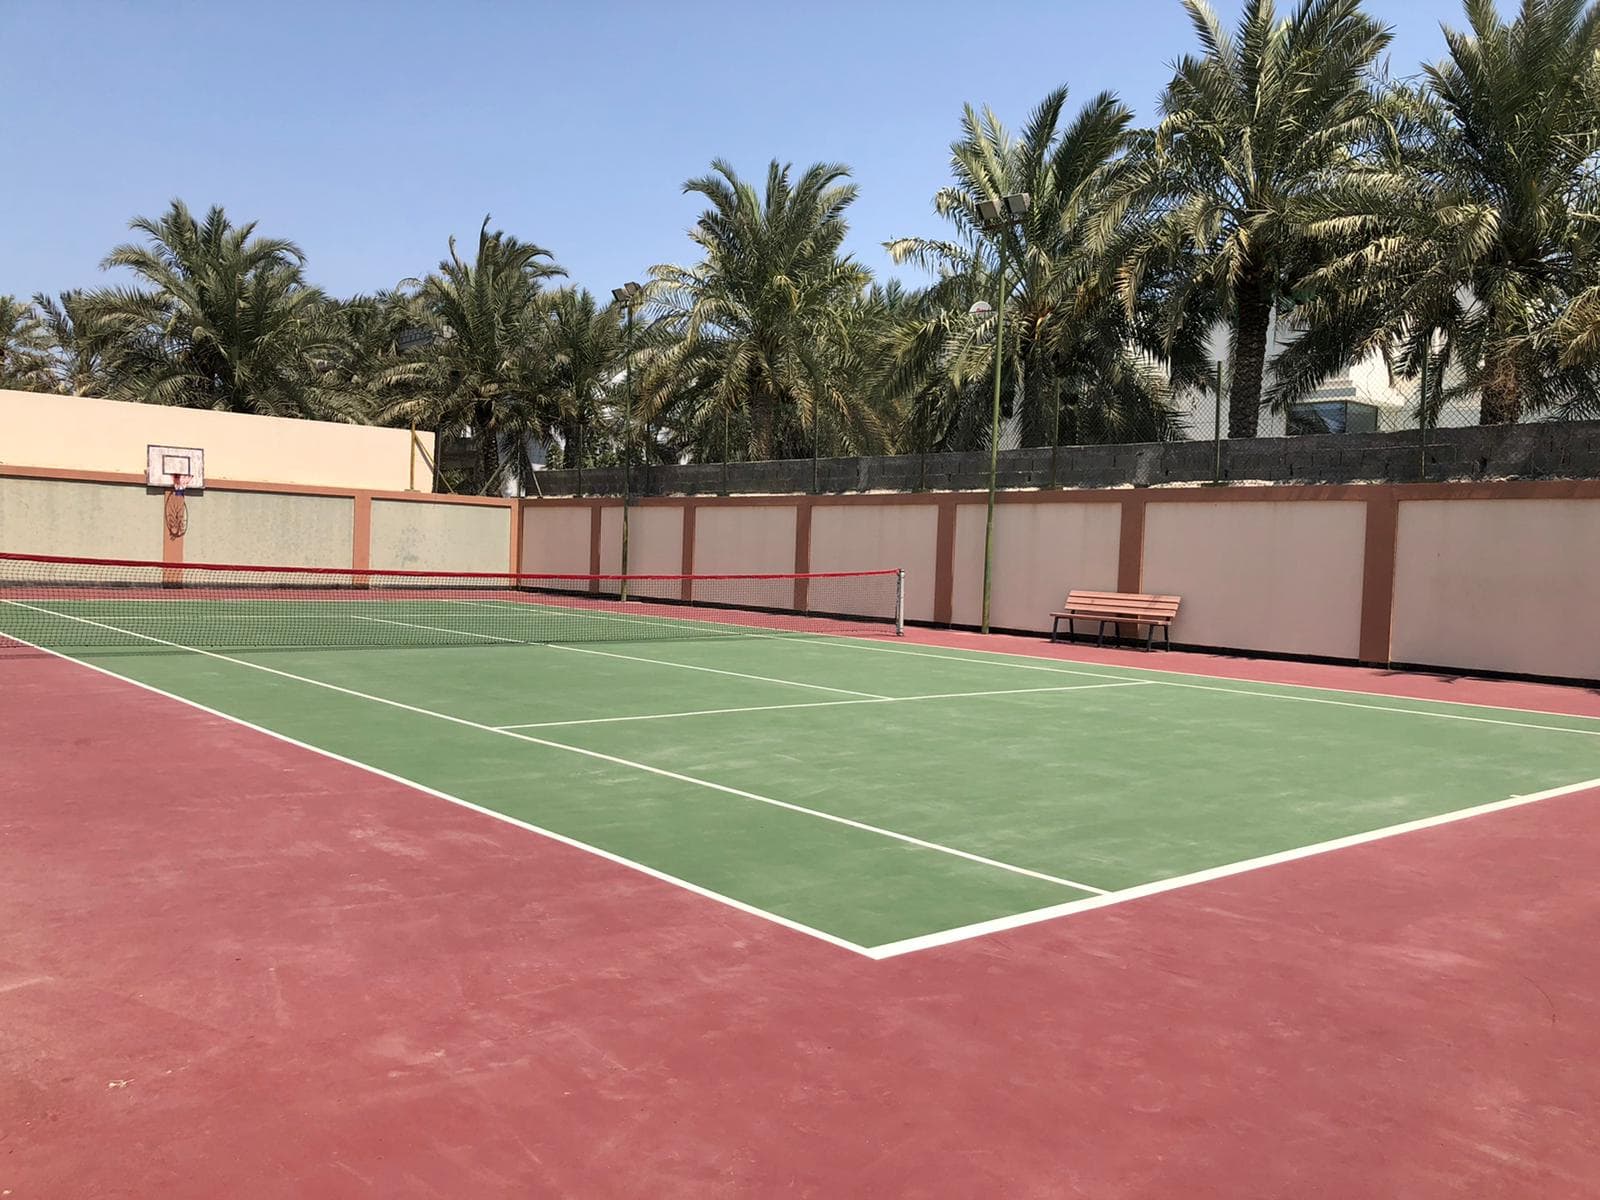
[{"left": 950, "top": 504, "right": 1122, "bottom": 629}]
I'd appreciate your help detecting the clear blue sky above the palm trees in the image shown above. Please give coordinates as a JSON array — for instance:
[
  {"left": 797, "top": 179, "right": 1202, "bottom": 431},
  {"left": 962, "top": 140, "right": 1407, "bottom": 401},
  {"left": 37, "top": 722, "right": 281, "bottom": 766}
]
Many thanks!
[{"left": 0, "top": 0, "right": 1465, "bottom": 305}]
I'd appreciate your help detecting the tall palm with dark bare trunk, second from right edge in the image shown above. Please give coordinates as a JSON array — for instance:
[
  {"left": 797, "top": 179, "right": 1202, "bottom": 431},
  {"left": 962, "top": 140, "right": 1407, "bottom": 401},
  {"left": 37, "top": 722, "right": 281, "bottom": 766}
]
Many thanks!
[{"left": 1123, "top": 0, "right": 1390, "bottom": 437}]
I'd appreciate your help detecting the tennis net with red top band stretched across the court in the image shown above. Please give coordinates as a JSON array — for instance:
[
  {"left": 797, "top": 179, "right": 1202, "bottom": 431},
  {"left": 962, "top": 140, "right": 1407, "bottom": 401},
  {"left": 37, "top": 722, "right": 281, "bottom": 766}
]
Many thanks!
[{"left": 0, "top": 554, "right": 904, "bottom": 651}]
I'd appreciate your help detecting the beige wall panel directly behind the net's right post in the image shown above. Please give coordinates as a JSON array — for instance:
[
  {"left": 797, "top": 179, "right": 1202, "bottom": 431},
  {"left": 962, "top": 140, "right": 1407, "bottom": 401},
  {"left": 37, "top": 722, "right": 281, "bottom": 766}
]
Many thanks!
[{"left": 811, "top": 504, "right": 939, "bottom": 621}]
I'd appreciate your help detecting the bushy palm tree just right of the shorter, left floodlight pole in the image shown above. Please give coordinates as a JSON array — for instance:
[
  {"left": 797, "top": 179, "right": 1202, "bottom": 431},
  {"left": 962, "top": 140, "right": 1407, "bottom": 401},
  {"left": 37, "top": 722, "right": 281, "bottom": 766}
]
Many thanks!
[{"left": 646, "top": 158, "right": 885, "bottom": 458}]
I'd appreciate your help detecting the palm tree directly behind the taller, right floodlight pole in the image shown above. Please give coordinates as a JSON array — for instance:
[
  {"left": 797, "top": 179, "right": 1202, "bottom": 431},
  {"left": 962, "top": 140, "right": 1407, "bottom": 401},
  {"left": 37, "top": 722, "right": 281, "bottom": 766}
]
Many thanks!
[{"left": 888, "top": 88, "right": 1198, "bottom": 448}]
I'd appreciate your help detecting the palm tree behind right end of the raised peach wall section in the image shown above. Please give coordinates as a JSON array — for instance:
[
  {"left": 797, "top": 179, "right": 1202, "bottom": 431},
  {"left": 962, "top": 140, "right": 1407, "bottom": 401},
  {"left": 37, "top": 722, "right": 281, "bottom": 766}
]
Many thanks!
[{"left": 378, "top": 218, "right": 566, "bottom": 494}]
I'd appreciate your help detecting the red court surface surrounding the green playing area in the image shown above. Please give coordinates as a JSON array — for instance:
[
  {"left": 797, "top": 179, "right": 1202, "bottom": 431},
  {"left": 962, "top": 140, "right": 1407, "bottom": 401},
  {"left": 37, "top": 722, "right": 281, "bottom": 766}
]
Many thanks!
[{"left": 0, "top": 643, "right": 1600, "bottom": 1200}]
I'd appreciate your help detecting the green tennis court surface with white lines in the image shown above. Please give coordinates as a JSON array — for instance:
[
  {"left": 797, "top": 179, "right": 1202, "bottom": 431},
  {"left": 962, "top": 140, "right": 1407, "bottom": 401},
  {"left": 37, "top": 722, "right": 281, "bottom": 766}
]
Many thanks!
[{"left": 0, "top": 600, "right": 1600, "bottom": 950}]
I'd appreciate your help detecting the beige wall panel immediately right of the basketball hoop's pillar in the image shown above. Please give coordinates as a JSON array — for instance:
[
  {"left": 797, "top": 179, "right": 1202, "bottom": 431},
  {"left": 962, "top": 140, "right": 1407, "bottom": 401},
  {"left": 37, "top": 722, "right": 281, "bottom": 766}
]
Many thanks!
[{"left": 184, "top": 488, "right": 355, "bottom": 566}]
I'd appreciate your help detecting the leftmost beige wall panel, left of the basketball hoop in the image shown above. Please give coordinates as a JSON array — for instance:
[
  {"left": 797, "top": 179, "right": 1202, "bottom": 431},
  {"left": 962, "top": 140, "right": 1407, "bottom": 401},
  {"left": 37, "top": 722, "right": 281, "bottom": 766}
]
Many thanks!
[{"left": 0, "top": 477, "right": 165, "bottom": 558}]
